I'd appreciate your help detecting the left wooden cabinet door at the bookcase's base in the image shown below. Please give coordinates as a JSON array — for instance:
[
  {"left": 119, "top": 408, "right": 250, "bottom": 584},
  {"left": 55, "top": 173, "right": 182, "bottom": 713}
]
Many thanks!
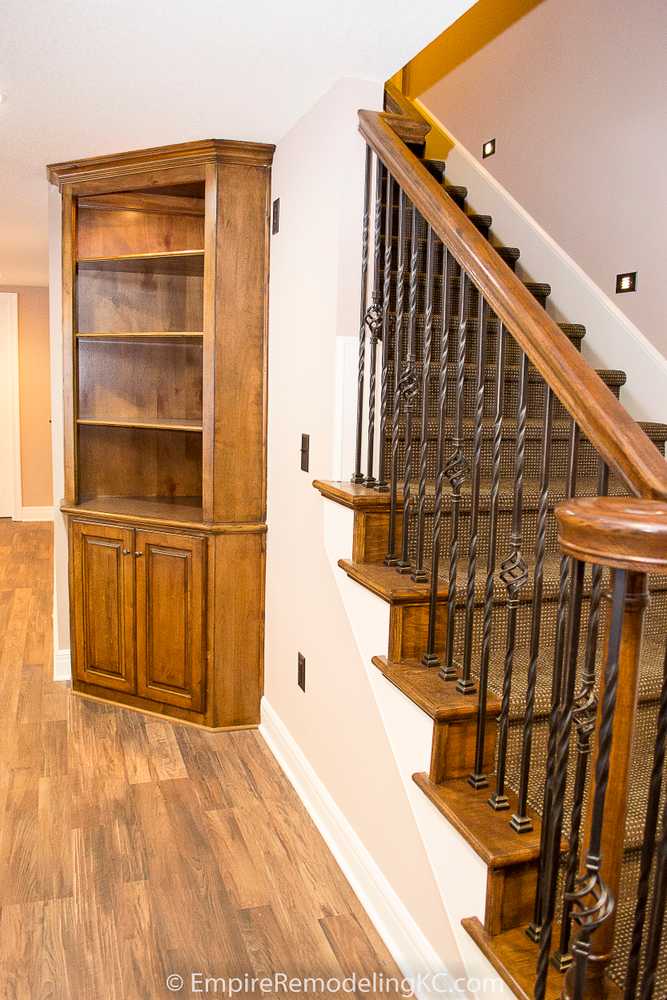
[{"left": 71, "top": 521, "right": 135, "bottom": 692}]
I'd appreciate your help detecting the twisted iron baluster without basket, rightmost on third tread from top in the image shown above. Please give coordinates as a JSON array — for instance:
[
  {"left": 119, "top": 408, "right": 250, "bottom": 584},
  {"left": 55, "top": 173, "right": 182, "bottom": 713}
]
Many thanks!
[{"left": 456, "top": 292, "right": 487, "bottom": 694}]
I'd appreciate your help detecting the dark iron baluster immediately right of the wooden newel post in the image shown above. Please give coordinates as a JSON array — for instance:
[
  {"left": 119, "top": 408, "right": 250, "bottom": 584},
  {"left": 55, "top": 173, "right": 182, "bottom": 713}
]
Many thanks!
[{"left": 625, "top": 636, "right": 667, "bottom": 1000}]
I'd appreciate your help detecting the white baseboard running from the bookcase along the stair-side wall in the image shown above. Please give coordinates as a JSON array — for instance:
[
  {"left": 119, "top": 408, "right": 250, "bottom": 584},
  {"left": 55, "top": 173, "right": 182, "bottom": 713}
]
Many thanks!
[{"left": 259, "top": 698, "right": 463, "bottom": 1000}]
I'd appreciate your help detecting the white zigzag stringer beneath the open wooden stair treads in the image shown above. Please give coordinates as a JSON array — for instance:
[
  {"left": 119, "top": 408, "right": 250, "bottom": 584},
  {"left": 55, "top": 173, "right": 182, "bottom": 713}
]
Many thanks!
[{"left": 323, "top": 501, "right": 515, "bottom": 998}]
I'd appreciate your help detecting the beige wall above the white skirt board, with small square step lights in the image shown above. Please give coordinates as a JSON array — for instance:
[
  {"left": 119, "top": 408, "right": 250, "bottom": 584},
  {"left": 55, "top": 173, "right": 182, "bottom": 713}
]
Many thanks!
[{"left": 408, "top": 0, "right": 667, "bottom": 355}]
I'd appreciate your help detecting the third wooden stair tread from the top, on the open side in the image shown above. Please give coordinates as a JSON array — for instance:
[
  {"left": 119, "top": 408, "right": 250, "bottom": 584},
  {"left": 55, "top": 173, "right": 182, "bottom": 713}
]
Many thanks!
[{"left": 373, "top": 656, "right": 500, "bottom": 722}]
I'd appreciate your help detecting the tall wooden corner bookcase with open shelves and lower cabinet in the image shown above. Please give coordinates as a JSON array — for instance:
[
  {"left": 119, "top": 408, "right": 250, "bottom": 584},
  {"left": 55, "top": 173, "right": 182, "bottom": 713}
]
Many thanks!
[{"left": 48, "top": 140, "right": 273, "bottom": 729}]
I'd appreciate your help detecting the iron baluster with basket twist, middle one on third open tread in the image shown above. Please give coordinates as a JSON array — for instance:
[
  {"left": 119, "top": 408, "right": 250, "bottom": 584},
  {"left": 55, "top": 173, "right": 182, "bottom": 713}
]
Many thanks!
[{"left": 440, "top": 267, "right": 469, "bottom": 681}]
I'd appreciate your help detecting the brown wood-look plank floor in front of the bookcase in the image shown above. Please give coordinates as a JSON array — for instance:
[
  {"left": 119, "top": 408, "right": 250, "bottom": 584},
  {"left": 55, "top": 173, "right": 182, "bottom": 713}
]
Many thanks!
[{"left": 0, "top": 520, "right": 408, "bottom": 1000}]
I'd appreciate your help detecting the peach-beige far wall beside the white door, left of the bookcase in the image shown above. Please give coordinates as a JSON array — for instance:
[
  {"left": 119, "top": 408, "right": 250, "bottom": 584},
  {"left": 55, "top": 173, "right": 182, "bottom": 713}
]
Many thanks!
[{"left": 0, "top": 285, "right": 53, "bottom": 507}]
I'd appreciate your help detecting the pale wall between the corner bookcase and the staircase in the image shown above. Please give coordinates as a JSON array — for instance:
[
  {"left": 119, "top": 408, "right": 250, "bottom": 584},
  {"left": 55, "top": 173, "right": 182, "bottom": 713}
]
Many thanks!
[{"left": 266, "top": 80, "right": 470, "bottom": 984}]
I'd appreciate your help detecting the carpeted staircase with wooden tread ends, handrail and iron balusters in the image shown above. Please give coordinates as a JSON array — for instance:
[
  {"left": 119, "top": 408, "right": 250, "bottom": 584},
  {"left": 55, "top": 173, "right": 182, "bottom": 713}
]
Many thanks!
[{"left": 314, "top": 91, "right": 667, "bottom": 1000}]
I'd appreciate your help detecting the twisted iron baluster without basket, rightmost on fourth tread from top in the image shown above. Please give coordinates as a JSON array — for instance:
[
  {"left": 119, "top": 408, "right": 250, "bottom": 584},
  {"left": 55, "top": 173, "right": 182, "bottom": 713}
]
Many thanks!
[{"left": 510, "top": 385, "right": 553, "bottom": 833}]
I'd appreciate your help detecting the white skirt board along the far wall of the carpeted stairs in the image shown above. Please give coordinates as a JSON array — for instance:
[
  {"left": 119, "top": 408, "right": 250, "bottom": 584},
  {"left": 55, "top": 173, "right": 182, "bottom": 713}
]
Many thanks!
[{"left": 414, "top": 99, "right": 667, "bottom": 421}]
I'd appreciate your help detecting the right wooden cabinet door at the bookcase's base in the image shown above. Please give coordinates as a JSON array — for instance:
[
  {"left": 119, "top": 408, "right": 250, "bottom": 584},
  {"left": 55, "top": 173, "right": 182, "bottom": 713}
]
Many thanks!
[{"left": 134, "top": 530, "right": 206, "bottom": 712}]
